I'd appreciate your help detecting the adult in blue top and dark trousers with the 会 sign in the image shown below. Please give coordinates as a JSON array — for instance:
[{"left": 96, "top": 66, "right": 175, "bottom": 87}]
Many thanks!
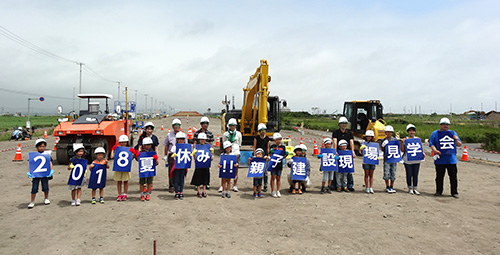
[{"left": 429, "top": 118, "right": 462, "bottom": 198}]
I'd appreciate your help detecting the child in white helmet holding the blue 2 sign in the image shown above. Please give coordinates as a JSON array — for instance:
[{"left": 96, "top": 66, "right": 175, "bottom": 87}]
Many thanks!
[{"left": 28, "top": 139, "right": 54, "bottom": 209}]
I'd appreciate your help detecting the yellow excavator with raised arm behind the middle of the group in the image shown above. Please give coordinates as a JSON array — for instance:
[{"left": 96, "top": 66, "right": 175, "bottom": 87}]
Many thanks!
[{"left": 220, "top": 59, "right": 286, "bottom": 149}]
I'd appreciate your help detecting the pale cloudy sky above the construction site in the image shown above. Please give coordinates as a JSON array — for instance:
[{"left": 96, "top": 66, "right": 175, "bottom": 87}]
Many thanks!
[{"left": 0, "top": 0, "right": 500, "bottom": 113}]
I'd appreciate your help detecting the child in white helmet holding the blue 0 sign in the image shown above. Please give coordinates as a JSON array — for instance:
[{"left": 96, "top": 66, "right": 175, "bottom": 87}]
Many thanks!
[{"left": 68, "top": 143, "right": 87, "bottom": 206}]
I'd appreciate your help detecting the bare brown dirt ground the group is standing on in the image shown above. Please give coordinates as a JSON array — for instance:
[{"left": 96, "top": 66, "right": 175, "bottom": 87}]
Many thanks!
[{"left": 0, "top": 118, "right": 500, "bottom": 254}]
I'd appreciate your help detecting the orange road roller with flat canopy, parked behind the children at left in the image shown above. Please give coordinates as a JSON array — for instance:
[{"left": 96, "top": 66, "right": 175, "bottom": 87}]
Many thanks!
[{"left": 54, "top": 94, "right": 133, "bottom": 164}]
